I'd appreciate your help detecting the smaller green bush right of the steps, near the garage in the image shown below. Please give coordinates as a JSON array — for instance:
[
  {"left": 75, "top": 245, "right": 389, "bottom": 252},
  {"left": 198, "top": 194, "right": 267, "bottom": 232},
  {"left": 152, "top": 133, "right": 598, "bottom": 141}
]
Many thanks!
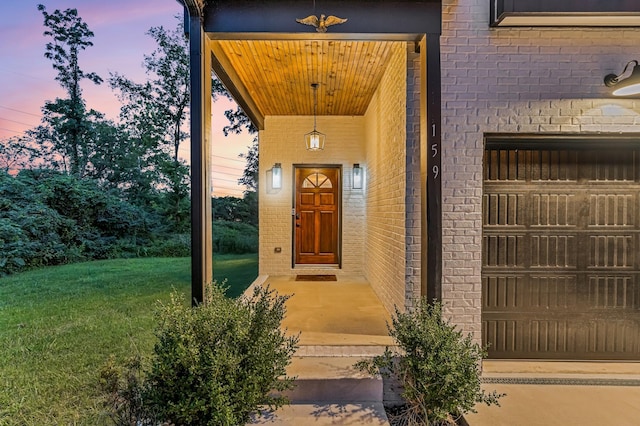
[{"left": 356, "top": 300, "right": 503, "bottom": 425}]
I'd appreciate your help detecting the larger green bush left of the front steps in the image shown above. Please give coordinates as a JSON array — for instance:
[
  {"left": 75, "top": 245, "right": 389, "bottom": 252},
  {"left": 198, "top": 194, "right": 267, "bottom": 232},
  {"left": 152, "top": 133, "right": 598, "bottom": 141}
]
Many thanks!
[{"left": 101, "top": 285, "right": 298, "bottom": 426}]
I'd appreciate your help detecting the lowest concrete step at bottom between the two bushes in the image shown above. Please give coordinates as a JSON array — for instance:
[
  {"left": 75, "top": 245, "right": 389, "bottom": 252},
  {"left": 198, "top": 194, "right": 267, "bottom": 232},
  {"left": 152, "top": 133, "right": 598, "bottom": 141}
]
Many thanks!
[{"left": 251, "top": 402, "right": 389, "bottom": 426}]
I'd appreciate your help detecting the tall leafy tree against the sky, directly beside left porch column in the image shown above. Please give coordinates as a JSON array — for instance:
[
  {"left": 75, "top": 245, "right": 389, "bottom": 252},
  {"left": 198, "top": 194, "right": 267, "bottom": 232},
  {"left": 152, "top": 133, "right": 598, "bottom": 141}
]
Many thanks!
[{"left": 109, "top": 24, "right": 190, "bottom": 229}]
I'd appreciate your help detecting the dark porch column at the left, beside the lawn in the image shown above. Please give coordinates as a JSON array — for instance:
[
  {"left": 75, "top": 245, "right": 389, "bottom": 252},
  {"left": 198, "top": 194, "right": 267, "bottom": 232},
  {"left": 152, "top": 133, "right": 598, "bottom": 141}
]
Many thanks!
[{"left": 189, "top": 13, "right": 213, "bottom": 305}]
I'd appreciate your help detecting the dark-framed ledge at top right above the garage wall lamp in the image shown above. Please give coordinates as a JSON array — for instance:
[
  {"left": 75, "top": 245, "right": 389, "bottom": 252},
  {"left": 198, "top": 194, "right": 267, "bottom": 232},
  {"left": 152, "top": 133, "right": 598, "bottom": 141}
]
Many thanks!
[{"left": 490, "top": 0, "right": 640, "bottom": 27}]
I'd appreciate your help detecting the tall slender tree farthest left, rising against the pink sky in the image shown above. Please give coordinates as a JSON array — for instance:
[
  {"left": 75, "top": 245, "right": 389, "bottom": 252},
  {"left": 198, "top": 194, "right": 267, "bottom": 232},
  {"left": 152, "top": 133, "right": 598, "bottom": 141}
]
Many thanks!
[{"left": 32, "top": 4, "right": 102, "bottom": 177}]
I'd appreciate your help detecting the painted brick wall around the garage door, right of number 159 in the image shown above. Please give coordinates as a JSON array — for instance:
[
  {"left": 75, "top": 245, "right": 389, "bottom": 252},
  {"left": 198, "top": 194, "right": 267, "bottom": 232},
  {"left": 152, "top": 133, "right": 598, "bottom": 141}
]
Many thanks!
[{"left": 441, "top": 0, "right": 640, "bottom": 339}]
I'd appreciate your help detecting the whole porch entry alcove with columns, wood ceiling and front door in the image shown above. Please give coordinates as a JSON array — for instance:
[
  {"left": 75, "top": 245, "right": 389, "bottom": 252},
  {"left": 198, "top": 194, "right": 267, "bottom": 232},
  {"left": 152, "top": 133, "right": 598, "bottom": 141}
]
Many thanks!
[{"left": 181, "top": 0, "right": 442, "bottom": 312}]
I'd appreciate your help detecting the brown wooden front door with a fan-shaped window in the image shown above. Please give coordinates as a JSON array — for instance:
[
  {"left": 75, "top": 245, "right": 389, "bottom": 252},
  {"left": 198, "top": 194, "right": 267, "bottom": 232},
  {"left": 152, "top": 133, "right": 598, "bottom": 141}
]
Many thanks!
[{"left": 294, "top": 167, "right": 340, "bottom": 264}]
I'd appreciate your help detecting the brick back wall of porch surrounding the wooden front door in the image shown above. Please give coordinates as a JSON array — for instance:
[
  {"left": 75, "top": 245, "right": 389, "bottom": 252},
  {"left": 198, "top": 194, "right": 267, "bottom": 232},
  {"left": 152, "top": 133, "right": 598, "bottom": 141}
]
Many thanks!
[{"left": 259, "top": 116, "right": 365, "bottom": 276}]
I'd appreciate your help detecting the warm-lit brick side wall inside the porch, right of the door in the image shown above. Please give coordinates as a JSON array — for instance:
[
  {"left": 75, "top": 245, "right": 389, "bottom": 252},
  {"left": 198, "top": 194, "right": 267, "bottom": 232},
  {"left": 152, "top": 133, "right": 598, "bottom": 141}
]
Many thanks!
[{"left": 364, "top": 43, "right": 407, "bottom": 312}]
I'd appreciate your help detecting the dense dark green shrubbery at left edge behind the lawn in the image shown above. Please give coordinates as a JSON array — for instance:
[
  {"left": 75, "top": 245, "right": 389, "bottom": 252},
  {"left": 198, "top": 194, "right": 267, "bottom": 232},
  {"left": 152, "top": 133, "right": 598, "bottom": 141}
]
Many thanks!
[{"left": 0, "top": 170, "right": 159, "bottom": 275}]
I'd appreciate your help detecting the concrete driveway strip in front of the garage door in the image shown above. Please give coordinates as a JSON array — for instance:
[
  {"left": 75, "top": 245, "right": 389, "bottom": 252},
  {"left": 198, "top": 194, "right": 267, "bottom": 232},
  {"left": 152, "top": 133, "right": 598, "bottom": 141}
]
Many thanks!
[{"left": 465, "top": 361, "right": 640, "bottom": 426}]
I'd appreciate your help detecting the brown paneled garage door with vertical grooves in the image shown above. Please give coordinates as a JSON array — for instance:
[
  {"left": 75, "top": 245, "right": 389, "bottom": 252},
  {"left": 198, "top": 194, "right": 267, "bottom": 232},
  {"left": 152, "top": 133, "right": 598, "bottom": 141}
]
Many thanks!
[{"left": 482, "top": 143, "right": 640, "bottom": 360}]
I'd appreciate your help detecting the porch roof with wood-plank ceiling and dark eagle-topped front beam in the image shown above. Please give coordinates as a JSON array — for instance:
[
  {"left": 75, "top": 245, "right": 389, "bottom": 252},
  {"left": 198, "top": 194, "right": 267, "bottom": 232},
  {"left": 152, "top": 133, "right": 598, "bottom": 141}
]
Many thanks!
[{"left": 202, "top": 0, "right": 442, "bottom": 128}]
